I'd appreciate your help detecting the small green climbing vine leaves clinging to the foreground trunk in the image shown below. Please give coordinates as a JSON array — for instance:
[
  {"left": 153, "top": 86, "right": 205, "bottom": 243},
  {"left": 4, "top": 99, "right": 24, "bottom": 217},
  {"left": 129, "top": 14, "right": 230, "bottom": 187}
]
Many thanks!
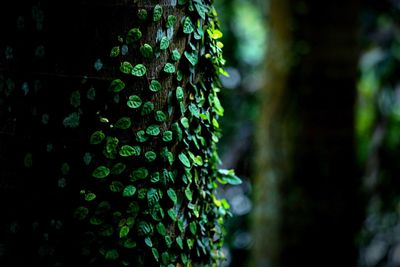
[{"left": 73, "top": 0, "right": 240, "bottom": 266}]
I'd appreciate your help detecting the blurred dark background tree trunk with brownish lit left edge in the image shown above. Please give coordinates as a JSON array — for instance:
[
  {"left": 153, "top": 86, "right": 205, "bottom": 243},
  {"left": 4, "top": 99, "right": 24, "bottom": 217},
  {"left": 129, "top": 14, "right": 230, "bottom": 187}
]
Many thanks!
[{"left": 251, "top": 0, "right": 362, "bottom": 267}]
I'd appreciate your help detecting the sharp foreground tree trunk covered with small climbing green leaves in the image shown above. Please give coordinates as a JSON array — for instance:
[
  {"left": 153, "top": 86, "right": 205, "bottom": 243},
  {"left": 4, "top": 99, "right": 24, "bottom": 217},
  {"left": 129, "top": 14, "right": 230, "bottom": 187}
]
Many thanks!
[{"left": 0, "top": 0, "right": 226, "bottom": 266}]
